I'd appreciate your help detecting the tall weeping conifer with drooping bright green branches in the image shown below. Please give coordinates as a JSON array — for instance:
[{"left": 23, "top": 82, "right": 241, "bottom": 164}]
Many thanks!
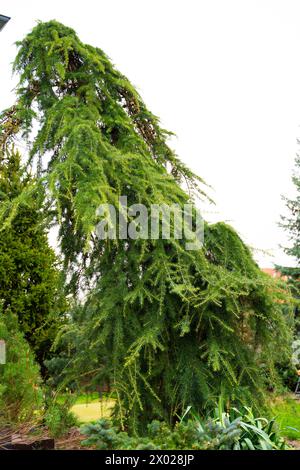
[{"left": 1, "top": 21, "right": 289, "bottom": 429}]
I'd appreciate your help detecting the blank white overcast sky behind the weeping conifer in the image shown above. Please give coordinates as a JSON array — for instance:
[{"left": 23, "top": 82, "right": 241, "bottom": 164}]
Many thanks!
[{"left": 0, "top": 0, "right": 300, "bottom": 267}]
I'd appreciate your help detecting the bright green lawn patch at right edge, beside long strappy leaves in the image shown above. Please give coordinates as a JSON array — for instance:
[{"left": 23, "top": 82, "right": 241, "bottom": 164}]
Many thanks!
[{"left": 271, "top": 396, "right": 300, "bottom": 441}]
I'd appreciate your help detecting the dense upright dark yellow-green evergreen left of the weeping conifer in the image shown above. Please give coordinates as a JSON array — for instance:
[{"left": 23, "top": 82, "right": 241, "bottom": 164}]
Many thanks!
[{"left": 0, "top": 149, "right": 66, "bottom": 373}]
